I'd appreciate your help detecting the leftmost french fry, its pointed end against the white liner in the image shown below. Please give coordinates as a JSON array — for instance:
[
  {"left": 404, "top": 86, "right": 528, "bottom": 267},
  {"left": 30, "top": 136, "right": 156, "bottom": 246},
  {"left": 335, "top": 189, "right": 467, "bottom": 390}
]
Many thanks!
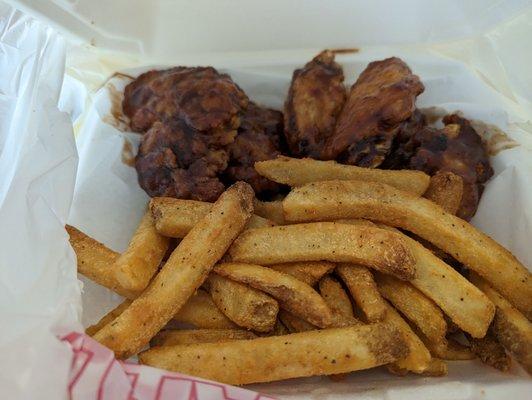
[{"left": 65, "top": 225, "right": 136, "bottom": 298}]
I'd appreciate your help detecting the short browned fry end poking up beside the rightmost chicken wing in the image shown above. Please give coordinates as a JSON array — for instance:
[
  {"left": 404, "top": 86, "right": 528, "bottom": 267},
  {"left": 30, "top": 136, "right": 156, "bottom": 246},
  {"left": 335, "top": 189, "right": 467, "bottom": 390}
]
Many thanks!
[{"left": 423, "top": 171, "right": 464, "bottom": 215}]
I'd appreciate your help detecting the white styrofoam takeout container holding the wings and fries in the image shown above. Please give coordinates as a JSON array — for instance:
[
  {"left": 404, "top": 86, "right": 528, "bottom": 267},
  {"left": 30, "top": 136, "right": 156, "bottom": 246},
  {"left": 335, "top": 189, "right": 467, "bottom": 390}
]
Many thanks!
[{"left": 5, "top": 0, "right": 532, "bottom": 399}]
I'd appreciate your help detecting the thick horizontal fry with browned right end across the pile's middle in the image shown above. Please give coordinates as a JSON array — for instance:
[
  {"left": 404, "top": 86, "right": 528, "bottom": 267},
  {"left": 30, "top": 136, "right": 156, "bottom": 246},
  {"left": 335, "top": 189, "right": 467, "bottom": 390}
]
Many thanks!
[{"left": 229, "top": 222, "right": 415, "bottom": 280}]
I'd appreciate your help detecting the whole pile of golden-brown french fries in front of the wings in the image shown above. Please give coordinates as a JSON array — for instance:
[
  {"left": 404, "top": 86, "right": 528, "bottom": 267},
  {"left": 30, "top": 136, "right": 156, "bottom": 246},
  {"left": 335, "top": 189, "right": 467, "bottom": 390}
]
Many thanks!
[{"left": 67, "top": 157, "right": 532, "bottom": 385}]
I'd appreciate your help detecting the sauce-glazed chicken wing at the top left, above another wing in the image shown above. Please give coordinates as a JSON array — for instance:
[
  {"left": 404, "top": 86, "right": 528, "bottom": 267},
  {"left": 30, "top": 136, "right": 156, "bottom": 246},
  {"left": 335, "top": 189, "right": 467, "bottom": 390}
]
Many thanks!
[{"left": 123, "top": 67, "right": 248, "bottom": 132}]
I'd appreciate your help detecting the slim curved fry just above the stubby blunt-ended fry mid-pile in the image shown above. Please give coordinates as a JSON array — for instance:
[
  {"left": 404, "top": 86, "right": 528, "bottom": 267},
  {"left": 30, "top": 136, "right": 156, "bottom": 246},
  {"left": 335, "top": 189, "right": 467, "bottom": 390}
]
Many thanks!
[{"left": 214, "top": 263, "right": 332, "bottom": 328}]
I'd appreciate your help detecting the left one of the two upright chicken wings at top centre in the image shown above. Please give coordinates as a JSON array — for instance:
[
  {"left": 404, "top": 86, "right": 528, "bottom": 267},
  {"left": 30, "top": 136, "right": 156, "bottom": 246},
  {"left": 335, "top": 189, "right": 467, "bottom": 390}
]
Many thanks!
[{"left": 284, "top": 50, "right": 346, "bottom": 158}]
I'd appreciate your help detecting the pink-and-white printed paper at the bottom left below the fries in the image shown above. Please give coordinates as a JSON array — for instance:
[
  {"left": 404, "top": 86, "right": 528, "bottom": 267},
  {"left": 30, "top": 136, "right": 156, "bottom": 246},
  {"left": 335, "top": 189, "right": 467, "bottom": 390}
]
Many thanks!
[{"left": 62, "top": 332, "right": 274, "bottom": 400}]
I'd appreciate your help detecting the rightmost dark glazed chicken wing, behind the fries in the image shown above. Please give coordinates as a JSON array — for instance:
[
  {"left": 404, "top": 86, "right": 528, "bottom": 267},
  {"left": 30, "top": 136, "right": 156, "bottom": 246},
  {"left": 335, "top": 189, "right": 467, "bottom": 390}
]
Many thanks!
[{"left": 408, "top": 114, "right": 493, "bottom": 220}]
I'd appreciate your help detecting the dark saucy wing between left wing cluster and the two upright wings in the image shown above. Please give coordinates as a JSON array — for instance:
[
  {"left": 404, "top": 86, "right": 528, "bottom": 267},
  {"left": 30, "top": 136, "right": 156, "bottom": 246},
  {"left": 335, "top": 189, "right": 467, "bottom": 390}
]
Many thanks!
[{"left": 224, "top": 102, "right": 285, "bottom": 197}]
